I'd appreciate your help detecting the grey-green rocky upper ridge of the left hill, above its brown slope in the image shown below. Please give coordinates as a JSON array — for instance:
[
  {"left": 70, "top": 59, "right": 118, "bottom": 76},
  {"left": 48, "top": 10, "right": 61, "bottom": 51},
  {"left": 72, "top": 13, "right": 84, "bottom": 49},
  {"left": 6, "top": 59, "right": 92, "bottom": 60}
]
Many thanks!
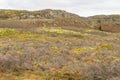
[{"left": 0, "top": 9, "right": 79, "bottom": 19}]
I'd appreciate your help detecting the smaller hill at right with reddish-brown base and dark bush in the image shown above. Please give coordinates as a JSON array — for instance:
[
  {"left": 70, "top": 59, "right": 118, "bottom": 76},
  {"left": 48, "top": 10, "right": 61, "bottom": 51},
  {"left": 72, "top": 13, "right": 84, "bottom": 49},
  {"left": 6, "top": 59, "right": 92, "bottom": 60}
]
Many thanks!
[{"left": 87, "top": 15, "right": 120, "bottom": 32}]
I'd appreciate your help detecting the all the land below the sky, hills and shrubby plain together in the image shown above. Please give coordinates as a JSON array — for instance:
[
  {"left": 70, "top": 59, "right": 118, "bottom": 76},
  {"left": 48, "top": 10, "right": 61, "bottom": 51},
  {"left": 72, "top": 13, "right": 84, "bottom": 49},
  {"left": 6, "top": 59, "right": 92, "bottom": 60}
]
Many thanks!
[{"left": 0, "top": 9, "right": 120, "bottom": 80}]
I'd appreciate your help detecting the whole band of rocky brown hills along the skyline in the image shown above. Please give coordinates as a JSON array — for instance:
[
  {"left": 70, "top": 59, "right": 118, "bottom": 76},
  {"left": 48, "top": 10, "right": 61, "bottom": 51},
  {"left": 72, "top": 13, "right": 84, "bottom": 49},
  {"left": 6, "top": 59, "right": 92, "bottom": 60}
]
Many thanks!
[{"left": 0, "top": 9, "right": 120, "bottom": 32}]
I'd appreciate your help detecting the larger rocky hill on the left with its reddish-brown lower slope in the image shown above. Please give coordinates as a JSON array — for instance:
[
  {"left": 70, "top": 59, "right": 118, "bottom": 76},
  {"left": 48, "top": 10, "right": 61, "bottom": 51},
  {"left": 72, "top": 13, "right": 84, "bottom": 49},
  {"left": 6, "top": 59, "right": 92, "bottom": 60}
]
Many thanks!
[{"left": 0, "top": 9, "right": 86, "bottom": 29}]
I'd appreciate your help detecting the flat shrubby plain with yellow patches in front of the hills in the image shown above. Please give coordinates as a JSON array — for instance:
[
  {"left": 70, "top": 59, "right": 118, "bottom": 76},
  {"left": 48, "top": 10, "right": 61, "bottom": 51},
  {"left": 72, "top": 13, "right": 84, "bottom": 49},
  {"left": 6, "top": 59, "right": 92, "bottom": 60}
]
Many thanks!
[{"left": 0, "top": 27, "right": 120, "bottom": 80}]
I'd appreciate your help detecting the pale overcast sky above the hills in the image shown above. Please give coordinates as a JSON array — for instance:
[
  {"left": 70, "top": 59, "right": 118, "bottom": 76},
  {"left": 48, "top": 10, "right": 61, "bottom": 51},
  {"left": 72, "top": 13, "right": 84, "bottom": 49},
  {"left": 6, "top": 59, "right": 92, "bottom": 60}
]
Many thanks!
[{"left": 0, "top": 0, "right": 120, "bottom": 17}]
